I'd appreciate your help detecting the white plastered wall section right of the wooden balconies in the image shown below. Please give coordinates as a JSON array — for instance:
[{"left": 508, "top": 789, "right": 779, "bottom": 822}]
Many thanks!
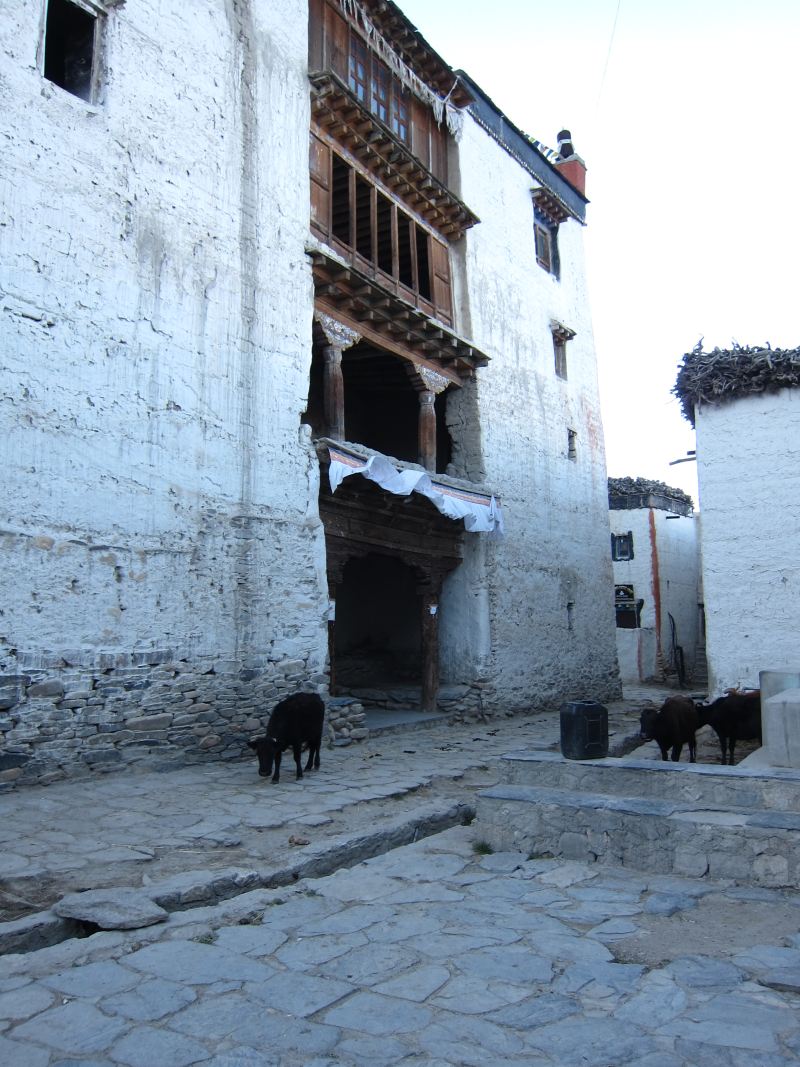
[{"left": 445, "top": 117, "right": 619, "bottom": 707}]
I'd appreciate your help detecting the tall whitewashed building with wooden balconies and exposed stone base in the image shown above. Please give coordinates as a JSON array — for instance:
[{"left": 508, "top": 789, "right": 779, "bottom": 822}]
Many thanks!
[{"left": 0, "top": 0, "right": 619, "bottom": 782}]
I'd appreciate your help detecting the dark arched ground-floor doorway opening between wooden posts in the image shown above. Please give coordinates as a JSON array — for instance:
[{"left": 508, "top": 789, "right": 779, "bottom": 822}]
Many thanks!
[{"left": 334, "top": 555, "right": 421, "bottom": 689}]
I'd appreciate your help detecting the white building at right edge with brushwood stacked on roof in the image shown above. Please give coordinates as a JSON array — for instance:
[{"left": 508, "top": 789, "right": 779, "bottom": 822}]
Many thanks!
[{"left": 673, "top": 345, "right": 800, "bottom": 694}]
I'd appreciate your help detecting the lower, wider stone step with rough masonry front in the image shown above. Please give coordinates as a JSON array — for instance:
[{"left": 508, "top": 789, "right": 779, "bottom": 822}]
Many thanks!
[{"left": 477, "top": 779, "right": 800, "bottom": 888}]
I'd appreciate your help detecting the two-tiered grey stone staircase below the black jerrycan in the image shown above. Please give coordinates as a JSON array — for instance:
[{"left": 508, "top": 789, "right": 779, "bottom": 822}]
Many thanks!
[{"left": 476, "top": 751, "right": 800, "bottom": 888}]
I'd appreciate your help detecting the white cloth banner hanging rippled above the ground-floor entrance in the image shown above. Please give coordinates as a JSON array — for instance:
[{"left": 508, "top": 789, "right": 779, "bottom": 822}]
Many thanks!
[{"left": 329, "top": 448, "right": 503, "bottom": 537}]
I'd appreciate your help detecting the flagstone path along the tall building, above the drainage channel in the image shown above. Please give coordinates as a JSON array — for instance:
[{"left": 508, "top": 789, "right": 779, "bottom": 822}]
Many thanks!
[{"left": 0, "top": 690, "right": 659, "bottom": 921}]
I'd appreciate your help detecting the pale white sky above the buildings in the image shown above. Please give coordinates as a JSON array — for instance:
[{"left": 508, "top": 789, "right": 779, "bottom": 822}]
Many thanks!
[{"left": 399, "top": 0, "right": 800, "bottom": 504}]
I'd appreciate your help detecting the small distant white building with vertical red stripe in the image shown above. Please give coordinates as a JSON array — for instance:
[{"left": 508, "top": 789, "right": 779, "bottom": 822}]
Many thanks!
[{"left": 608, "top": 478, "right": 703, "bottom": 685}]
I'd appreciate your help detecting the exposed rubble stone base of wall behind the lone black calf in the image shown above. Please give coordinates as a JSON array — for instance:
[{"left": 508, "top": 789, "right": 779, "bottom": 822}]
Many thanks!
[{"left": 0, "top": 652, "right": 327, "bottom": 790}]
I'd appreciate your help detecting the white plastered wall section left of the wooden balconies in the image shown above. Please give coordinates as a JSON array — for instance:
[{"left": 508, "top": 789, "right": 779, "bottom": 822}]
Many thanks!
[{"left": 0, "top": 0, "right": 325, "bottom": 671}]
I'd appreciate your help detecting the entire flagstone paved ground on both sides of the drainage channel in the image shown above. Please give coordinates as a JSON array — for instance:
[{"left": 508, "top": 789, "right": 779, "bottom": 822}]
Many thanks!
[{"left": 0, "top": 687, "right": 800, "bottom": 1067}]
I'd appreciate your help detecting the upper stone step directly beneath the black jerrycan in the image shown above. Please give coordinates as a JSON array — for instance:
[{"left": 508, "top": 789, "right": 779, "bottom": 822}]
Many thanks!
[{"left": 500, "top": 749, "right": 800, "bottom": 812}]
